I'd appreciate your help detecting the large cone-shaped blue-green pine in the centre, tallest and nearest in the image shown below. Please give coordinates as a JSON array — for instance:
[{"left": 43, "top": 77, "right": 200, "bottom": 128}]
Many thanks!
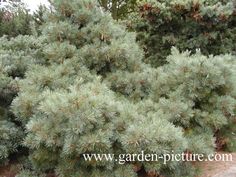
[{"left": 12, "top": 0, "right": 187, "bottom": 177}]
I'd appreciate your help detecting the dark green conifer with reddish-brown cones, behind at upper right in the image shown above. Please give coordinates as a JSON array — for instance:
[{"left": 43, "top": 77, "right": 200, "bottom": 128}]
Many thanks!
[{"left": 134, "top": 0, "right": 236, "bottom": 66}]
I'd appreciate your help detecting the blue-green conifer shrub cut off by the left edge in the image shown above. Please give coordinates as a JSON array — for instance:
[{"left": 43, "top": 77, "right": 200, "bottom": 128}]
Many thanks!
[{"left": 0, "top": 36, "right": 45, "bottom": 165}]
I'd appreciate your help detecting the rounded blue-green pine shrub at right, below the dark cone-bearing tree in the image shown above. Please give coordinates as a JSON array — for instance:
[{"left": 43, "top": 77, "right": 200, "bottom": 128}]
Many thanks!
[{"left": 151, "top": 48, "right": 236, "bottom": 154}]
